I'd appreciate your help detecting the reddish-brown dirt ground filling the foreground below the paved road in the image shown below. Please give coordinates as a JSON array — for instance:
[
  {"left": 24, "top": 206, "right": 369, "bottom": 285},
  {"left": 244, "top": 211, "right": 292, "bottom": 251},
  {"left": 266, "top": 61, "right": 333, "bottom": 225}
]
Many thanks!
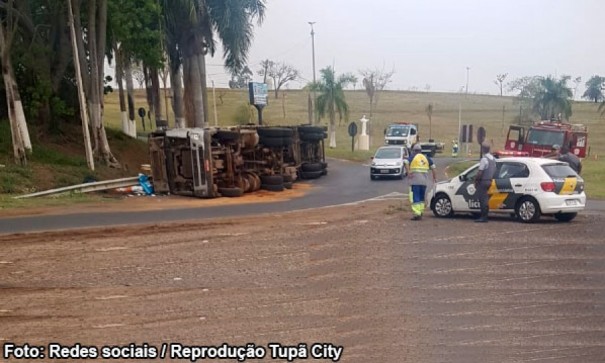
[{"left": 0, "top": 200, "right": 605, "bottom": 362}]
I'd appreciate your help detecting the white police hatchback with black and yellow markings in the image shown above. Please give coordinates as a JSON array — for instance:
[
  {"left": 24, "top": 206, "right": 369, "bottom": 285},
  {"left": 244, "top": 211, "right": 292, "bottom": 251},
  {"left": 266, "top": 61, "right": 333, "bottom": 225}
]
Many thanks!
[{"left": 431, "top": 157, "right": 586, "bottom": 223}]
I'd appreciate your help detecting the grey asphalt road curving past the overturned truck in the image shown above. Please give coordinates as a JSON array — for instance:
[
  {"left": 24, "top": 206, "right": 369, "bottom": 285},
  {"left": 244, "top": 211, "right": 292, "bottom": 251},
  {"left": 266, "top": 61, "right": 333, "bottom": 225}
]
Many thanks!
[{"left": 0, "top": 157, "right": 605, "bottom": 233}]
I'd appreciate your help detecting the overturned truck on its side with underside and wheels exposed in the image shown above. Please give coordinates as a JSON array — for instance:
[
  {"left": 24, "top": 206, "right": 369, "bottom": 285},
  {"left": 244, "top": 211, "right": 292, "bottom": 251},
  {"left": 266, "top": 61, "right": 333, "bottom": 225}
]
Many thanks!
[{"left": 149, "top": 125, "right": 328, "bottom": 198}]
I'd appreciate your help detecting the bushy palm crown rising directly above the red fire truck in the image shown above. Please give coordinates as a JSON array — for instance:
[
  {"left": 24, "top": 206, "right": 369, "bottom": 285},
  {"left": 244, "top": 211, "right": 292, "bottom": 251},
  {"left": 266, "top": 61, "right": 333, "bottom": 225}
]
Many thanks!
[{"left": 533, "top": 76, "right": 573, "bottom": 120}]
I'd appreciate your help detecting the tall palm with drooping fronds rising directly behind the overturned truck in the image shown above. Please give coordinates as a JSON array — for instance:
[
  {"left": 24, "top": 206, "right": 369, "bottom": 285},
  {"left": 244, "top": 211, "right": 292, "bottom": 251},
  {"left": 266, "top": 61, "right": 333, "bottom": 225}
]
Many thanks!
[{"left": 162, "top": 0, "right": 265, "bottom": 127}]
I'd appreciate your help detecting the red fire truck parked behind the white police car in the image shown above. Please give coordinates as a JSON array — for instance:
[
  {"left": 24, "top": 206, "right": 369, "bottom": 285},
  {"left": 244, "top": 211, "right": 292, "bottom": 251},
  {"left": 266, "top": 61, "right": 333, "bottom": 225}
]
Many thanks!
[{"left": 495, "top": 121, "right": 588, "bottom": 158}]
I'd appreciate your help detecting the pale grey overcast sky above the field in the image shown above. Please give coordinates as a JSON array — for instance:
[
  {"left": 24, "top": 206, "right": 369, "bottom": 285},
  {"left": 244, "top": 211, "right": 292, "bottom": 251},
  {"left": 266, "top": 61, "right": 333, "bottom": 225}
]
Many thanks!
[{"left": 207, "top": 0, "right": 605, "bottom": 95}]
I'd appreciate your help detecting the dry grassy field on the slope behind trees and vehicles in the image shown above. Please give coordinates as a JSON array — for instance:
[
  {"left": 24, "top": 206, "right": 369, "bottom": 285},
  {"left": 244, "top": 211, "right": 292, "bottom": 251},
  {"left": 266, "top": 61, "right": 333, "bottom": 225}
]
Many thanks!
[{"left": 105, "top": 89, "right": 605, "bottom": 198}]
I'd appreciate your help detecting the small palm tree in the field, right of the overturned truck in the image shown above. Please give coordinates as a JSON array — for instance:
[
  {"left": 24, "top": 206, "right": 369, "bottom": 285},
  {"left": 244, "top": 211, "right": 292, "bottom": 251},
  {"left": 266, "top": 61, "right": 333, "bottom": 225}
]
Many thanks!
[{"left": 311, "top": 67, "right": 355, "bottom": 148}]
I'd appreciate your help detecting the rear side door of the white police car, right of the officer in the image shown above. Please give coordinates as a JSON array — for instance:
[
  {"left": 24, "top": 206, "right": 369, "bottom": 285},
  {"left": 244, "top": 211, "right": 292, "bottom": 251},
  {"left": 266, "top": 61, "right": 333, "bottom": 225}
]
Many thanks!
[{"left": 488, "top": 161, "right": 529, "bottom": 210}]
